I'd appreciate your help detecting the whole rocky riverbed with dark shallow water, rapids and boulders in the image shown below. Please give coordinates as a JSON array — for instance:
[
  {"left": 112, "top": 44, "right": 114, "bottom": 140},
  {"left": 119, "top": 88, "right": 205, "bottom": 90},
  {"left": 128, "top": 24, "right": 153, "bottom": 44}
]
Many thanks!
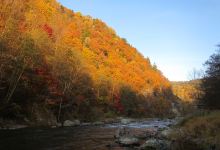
[{"left": 0, "top": 118, "right": 180, "bottom": 150}]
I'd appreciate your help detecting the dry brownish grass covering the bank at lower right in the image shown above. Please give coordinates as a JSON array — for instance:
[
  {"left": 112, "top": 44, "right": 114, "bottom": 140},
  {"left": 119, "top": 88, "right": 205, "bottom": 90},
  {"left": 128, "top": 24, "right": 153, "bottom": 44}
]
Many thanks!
[{"left": 171, "top": 111, "right": 220, "bottom": 150}]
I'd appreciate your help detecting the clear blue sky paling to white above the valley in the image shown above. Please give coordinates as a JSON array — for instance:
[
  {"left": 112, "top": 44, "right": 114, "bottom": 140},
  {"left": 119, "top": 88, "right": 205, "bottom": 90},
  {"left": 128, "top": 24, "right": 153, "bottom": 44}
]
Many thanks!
[{"left": 58, "top": 0, "right": 220, "bottom": 81}]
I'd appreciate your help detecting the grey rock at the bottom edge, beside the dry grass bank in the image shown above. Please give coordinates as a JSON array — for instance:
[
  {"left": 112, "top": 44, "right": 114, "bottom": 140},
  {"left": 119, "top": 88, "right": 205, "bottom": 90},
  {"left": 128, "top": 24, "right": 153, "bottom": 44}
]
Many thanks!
[{"left": 140, "top": 139, "right": 170, "bottom": 150}]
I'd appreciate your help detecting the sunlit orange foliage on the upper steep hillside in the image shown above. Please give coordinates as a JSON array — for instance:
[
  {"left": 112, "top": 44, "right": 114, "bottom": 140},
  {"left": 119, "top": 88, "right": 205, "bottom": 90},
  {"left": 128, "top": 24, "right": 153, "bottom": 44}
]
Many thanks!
[{"left": 0, "top": 0, "right": 173, "bottom": 118}]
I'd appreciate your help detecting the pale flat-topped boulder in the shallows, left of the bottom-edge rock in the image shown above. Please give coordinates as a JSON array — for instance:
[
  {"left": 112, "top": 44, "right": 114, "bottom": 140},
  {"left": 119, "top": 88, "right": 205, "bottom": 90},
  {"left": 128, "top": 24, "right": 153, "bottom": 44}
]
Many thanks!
[{"left": 116, "top": 136, "right": 140, "bottom": 146}]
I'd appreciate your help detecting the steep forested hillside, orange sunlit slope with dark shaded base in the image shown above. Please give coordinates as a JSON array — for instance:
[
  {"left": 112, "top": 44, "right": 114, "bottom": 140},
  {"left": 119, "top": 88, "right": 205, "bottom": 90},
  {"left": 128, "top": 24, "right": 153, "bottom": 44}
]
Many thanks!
[{"left": 0, "top": 0, "right": 173, "bottom": 122}]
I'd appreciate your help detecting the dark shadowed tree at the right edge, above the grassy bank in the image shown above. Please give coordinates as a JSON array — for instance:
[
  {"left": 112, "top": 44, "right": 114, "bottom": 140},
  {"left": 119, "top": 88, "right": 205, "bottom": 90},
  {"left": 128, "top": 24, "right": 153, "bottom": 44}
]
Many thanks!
[{"left": 201, "top": 49, "right": 220, "bottom": 109}]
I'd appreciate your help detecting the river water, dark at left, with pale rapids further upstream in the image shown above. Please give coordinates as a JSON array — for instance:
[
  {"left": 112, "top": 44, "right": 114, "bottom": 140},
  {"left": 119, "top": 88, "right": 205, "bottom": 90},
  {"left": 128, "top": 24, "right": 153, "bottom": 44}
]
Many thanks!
[{"left": 0, "top": 120, "right": 174, "bottom": 150}]
